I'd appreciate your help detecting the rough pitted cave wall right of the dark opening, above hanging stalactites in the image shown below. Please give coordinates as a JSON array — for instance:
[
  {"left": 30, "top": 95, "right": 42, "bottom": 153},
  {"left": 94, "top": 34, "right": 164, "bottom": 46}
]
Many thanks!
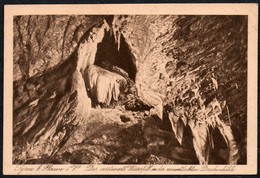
[{"left": 114, "top": 15, "right": 248, "bottom": 134}]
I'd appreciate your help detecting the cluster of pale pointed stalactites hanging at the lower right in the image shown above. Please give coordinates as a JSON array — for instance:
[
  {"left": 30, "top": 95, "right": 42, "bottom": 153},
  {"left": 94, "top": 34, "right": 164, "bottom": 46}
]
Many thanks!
[{"left": 169, "top": 75, "right": 239, "bottom": 164}]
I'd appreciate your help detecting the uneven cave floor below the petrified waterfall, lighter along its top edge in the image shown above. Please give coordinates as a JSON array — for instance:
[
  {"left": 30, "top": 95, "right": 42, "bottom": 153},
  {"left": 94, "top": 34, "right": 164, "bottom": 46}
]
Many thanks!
[{"left": 24, "top": 108, "right": 187, "bottom": 164}]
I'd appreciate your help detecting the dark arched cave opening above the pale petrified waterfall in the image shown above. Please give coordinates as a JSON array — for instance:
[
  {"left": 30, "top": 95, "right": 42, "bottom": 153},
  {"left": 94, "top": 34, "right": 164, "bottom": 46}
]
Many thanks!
[{"left": 94, "top": 31, "right": 137, "bottom": 81}]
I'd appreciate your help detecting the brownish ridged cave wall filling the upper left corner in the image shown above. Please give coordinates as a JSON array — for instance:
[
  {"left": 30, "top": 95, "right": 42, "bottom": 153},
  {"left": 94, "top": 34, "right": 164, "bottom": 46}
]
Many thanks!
[{"left": 13, "top": 15, "right": 104, "bottom": 80}]
